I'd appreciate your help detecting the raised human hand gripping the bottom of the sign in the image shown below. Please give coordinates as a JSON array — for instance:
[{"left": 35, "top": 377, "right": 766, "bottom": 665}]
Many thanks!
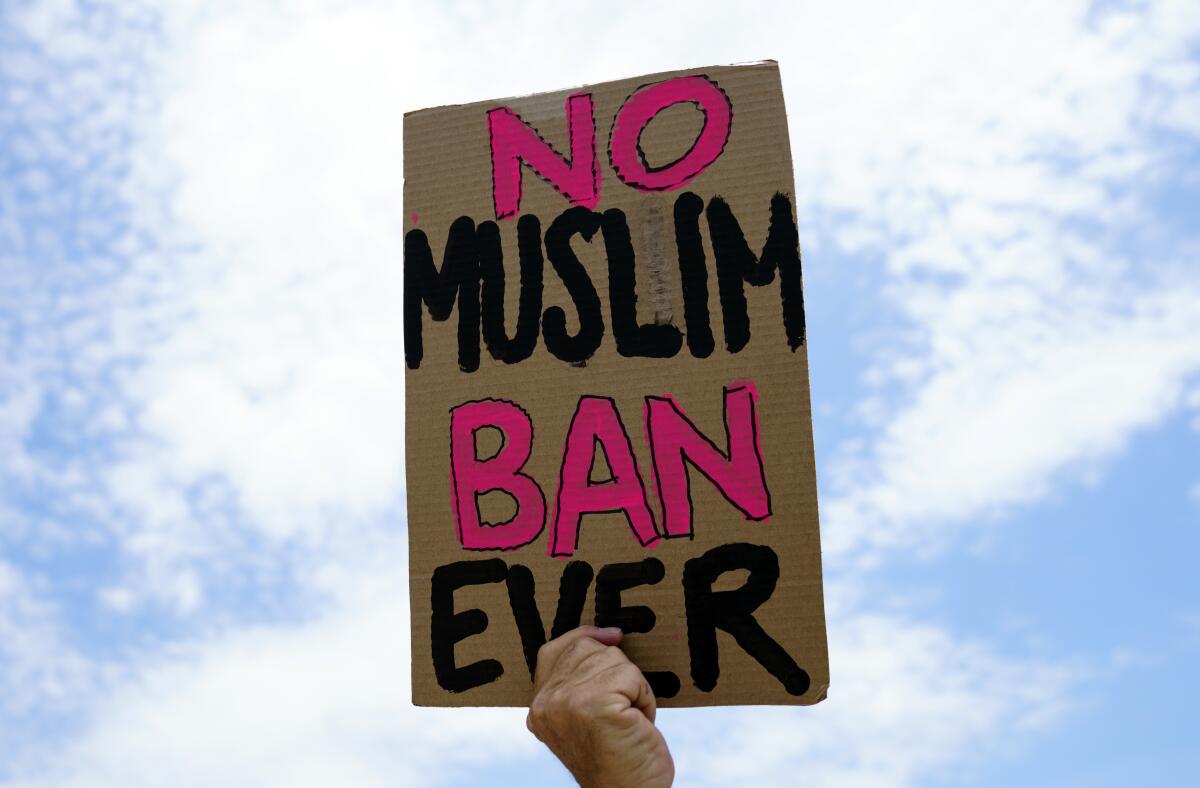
[{"left": 526, "top": 626, "right": 674, "bottom": 788}]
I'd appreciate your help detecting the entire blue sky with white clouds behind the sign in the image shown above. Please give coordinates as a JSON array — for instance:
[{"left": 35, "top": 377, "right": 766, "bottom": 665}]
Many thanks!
[{"left": 0, "top": 0, "right": 1200, "bottom": 788}]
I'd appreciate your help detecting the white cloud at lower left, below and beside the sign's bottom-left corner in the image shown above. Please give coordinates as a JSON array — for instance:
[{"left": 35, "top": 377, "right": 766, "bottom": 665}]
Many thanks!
[{"left": 4, "top": 551, "right": 544, "bottom": 788}]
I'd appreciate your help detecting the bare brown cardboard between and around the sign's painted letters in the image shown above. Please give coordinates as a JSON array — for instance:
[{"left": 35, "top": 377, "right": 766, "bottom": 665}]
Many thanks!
[{"left": 404, "top": 62, "right": 829, "bottom": 706}]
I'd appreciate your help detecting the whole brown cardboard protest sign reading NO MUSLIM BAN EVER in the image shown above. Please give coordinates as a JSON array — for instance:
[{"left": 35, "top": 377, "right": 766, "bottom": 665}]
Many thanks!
[{"left": 404, "top": 62, "right": 829, "bottom": 706}]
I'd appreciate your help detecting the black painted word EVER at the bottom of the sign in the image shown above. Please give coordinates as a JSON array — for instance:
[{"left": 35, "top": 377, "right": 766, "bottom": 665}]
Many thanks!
[{"left": 431, "top": 543, "right": 810, "bottom": 698}]
